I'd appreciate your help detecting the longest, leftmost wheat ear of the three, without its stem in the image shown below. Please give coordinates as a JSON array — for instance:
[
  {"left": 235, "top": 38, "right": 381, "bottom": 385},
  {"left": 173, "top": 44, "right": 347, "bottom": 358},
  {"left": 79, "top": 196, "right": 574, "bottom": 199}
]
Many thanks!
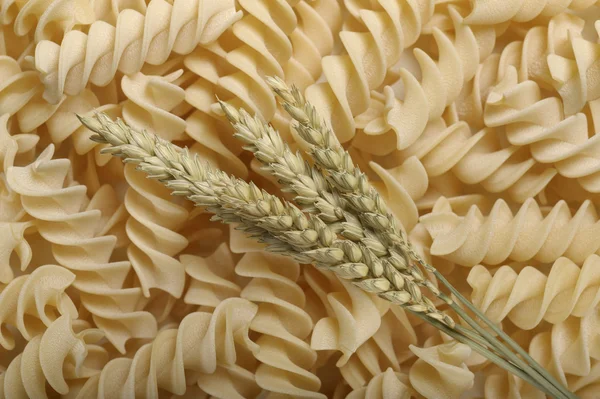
[{"left": 79, "top": 114, "right": 454, "bottom": 327}]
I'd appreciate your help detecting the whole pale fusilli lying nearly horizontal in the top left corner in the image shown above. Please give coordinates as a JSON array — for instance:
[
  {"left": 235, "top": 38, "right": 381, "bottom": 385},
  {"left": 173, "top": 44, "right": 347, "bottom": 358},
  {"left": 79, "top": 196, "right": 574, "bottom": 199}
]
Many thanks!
[{"left": 35, "top": 0, "right": 241, "bottom": 104}]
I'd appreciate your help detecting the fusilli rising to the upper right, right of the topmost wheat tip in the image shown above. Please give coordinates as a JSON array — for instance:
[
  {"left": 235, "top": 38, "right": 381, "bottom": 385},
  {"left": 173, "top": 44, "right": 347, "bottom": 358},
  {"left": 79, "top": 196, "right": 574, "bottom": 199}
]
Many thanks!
[{"left": 364, "top": 7, "right": 482, "bottom": 150}]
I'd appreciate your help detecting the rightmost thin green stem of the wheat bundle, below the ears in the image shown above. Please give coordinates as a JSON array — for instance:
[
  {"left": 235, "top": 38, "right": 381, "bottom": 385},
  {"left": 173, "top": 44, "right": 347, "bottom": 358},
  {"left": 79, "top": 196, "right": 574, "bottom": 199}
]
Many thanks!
[{"left": 433, "top": 270, "right": 578, "bottom": 399}]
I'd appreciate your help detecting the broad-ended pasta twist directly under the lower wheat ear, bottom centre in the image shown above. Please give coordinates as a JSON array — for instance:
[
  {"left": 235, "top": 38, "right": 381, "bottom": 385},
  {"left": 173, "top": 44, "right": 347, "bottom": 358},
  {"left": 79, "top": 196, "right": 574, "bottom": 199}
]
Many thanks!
[{"left": 304, "top": 267, "right": 389, "bottom": 367}]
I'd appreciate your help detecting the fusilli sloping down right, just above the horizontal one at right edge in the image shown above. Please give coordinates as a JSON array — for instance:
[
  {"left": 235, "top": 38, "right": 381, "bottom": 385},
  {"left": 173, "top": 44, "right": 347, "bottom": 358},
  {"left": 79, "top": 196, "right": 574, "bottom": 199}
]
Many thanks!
[{"left": 392, "top": 118, "right": 557, "bottom": 202}]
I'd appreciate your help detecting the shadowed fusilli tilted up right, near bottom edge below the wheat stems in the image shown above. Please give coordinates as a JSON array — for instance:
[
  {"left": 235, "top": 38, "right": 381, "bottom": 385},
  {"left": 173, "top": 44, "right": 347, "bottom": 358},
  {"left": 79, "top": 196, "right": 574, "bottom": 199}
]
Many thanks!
[{"left": 340, "top": 307, "right": 417, "bottom": 391}]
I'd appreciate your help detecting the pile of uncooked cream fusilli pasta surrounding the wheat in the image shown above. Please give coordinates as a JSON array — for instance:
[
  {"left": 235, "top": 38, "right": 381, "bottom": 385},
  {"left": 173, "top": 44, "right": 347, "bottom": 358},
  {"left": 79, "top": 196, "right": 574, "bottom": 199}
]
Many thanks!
[{"left": 0, "top": 0, "right": 600, "bottom": 399}]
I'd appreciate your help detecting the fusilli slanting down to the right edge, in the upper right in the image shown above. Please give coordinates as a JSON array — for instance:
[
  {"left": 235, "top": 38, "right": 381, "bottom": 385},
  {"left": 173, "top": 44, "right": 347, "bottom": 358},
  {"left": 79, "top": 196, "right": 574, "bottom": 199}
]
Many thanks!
[{"left": 484, "top": 67, "right": 600, "bottom": 193}]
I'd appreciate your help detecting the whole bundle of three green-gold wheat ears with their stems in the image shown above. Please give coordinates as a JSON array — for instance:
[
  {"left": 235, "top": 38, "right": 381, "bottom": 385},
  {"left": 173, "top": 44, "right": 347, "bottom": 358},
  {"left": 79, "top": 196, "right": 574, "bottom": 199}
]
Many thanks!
[{"left": 79, "top": 78, "right": 576, "bottom": 398}]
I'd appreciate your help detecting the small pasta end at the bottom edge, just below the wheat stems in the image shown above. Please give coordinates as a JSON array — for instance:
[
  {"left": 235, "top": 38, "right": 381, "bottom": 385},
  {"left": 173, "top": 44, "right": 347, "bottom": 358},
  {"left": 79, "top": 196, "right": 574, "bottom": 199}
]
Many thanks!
[{"left": 408, "top": 342, "right": 475, "bottom": 399}]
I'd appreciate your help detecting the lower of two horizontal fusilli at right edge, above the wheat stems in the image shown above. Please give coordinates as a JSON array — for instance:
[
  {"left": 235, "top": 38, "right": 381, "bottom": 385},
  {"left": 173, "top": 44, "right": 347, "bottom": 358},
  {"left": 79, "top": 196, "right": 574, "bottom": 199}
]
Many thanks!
[{"left": 467, "top": 254, "right": 600, "bottom": 330}]
